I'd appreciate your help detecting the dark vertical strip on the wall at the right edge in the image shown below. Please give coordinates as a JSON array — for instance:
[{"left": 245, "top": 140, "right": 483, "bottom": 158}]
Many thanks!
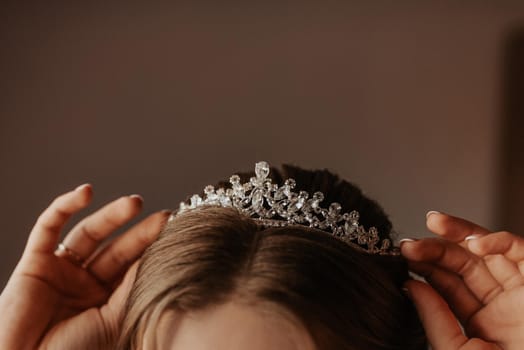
[{"left": 497, "top": 26, "right": 524, "bottom": 235}]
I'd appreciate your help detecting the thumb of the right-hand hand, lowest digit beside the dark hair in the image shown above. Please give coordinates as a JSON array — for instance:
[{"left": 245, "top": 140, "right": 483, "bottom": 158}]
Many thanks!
[{"left": 405, "top": 280, "right": 499, "bottom": 350}]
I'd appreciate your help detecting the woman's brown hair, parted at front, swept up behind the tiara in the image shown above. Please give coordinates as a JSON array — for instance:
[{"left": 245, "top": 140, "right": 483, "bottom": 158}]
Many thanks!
[{"left": 119, "top": 165, "right": 427, "bottom": 350}]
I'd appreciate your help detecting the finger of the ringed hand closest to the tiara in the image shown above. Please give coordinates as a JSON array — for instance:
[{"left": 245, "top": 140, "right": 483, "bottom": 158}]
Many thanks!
[{"left": 88, "top": 211, "right": 171, "bottom": 284}]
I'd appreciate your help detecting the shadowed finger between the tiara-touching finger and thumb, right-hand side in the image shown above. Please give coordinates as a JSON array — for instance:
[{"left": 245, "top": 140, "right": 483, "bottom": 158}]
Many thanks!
[{"left": 409, "top": 262, "right": 483, "bottom": 325}]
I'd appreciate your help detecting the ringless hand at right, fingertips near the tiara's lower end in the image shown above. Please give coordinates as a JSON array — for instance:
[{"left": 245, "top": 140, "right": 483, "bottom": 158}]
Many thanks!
[{"left": 401, "top": 212, "right": 524, "bottom": 350}]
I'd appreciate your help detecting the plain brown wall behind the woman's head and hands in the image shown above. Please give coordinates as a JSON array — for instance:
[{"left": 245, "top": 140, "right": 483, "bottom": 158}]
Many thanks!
[{"left": 0, "top": 1, "right": 524, "bottom": 283}]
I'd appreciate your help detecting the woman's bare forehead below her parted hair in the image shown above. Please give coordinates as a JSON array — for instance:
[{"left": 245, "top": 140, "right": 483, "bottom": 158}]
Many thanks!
[{"left": 151, "top": 302, "right": 315, "bottom": 350}]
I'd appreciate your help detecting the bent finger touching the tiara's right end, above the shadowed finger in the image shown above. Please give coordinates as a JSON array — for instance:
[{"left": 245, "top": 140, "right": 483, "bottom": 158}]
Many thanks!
[{"left": 401, "top": 238, "right": 503, "bottom": 304}]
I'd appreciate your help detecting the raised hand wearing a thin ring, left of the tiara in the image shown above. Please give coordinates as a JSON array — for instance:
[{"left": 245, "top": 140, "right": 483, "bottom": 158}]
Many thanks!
[{"left": 0, "top": 185, "right": 168, "bottom": 349}]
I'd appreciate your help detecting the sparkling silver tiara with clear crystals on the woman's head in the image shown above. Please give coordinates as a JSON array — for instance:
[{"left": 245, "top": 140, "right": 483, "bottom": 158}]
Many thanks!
[{"left": 172, "top": 162, "right": 400, "bottom": 255}]
